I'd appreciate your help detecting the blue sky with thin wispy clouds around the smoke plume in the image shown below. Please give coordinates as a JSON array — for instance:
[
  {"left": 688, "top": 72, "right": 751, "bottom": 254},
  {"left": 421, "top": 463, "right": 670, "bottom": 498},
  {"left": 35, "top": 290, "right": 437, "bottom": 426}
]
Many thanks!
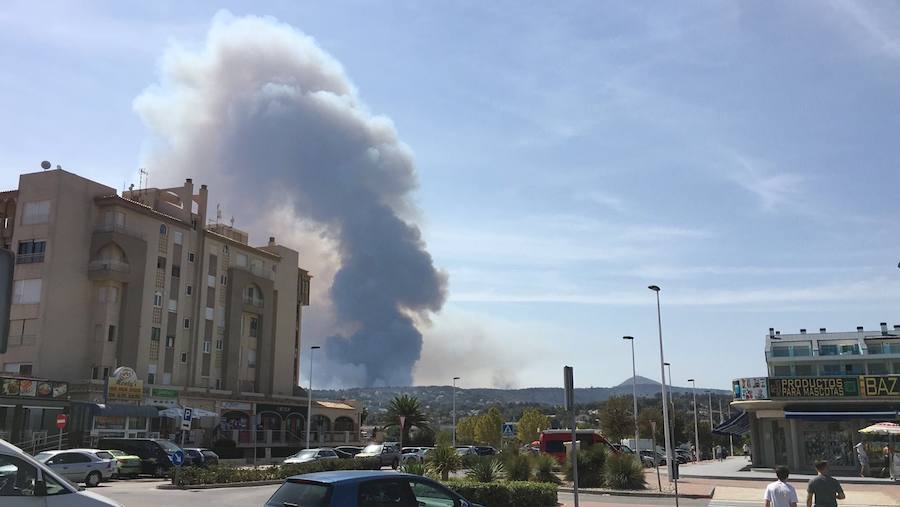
[{"left": 0, "top": 0, "right": 900, "bottom": 389}]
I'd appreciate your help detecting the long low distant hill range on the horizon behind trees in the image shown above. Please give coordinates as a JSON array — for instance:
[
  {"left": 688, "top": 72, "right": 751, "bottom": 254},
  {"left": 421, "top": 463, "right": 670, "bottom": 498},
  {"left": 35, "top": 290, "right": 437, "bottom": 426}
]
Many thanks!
[{"left": 314, "top": 376, "right": 732, "bottom": 422}]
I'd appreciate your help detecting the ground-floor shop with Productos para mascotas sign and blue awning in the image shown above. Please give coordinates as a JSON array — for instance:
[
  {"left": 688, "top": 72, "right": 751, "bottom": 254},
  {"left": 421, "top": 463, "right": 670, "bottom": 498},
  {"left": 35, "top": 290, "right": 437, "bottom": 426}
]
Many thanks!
[{"left": 732, "top": 375, "right": 900, "bottom": 475}]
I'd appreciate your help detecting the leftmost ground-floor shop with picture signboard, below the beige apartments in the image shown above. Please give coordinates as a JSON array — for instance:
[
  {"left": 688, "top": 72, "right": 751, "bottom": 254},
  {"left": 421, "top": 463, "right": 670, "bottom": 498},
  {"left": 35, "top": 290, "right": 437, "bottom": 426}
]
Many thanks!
[{"left": 0, "top": 376, "right": 70, "bottom": 447}]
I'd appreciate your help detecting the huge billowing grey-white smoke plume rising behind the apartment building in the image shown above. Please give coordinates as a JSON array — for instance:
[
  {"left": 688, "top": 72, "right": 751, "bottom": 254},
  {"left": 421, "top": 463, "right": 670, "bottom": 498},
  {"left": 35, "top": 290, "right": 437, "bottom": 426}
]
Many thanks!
[{"left": 134, "top": 12, "right": 447, "bottom": 385}]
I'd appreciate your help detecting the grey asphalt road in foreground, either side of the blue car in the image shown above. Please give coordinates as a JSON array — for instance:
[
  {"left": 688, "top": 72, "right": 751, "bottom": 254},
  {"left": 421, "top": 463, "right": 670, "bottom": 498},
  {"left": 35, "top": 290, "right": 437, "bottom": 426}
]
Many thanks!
[{"left": 91, "top": 479, "right": 709, "bottom": 507}]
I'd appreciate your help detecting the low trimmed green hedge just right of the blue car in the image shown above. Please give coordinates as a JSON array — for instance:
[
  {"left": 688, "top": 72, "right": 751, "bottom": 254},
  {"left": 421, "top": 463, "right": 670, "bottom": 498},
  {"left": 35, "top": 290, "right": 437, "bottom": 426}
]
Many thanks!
[{"left": 444, "top": 480, "right": 558, "bottom": 507}]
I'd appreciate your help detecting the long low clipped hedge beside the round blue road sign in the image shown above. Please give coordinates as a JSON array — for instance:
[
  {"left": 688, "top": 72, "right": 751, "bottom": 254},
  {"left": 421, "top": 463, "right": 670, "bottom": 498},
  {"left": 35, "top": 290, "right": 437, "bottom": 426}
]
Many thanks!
[{"left": 172, "top": 458, "right": 381, "bottom": 486}]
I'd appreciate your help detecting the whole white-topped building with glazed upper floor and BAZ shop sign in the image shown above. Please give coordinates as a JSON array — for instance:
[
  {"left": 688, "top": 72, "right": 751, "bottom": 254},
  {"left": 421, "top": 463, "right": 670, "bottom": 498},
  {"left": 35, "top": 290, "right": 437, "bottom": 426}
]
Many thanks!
[{"left": 732, "top": 323, "right": 900, "bottom": 473}]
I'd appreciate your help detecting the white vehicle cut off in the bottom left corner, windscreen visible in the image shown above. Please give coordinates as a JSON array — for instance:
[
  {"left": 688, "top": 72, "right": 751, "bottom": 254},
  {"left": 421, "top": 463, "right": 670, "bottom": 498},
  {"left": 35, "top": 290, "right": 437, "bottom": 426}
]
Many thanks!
[{"left": 0, "top": 440, "right": 122, "bottom": 507}]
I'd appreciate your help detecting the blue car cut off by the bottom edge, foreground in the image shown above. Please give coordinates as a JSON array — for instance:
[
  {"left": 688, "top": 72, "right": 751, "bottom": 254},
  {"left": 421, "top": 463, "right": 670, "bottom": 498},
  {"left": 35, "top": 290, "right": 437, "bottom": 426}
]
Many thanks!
[{"left": 266, "top": 470, "right": 482, "bottom": 507}]
